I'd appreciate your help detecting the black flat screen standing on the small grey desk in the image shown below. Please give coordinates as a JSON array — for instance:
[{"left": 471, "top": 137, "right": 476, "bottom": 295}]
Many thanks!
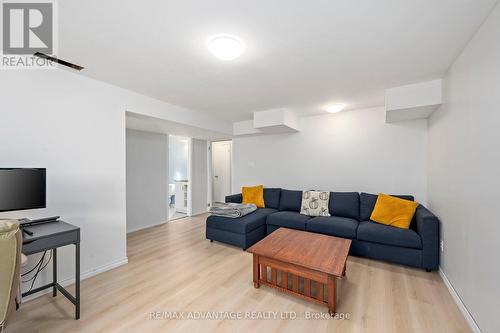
[{"left": 0, "top": 168, "right": 46, "bottom": 212}]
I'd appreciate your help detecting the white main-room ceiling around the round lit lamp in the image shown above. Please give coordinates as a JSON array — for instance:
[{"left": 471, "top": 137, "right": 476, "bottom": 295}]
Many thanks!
[{"left": 58, "top": 0, "right": 497, "bottom": 121}]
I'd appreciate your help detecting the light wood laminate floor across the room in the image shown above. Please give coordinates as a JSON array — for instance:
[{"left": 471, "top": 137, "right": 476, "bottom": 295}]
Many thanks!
[{"left": 7, "top": 215, "right": 469, "bottom": 333}]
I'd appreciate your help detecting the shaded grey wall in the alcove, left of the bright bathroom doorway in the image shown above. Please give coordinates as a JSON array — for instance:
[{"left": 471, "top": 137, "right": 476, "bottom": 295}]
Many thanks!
[{"left": 126, "top": 129, "right": 168, "bottom": 232}]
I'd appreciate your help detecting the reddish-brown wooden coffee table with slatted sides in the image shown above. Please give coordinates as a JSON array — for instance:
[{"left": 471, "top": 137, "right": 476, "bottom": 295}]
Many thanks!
[{"left": 247, "top": 228, "right": 351, "bottom": 314}]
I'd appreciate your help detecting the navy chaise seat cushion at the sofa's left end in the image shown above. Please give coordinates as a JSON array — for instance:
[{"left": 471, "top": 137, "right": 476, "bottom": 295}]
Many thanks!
[{"left": 207, "top": 208, "right": 277, "bottom": 234}]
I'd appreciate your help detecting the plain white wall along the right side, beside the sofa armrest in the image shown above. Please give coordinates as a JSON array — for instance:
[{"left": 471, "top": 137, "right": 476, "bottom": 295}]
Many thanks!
[{"left": 428, "top": 5, "right": 500, "bottom": 333}]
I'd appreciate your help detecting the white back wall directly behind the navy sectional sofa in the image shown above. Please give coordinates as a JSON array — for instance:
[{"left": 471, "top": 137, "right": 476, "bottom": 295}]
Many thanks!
[{"left": 233, "top": 107, "right": 427, "bottom": 204}]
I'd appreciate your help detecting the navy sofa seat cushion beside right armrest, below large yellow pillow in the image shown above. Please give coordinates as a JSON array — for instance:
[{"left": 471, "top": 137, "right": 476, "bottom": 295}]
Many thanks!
[{"left": 357, "top": 221, "right": 422, "bottom": 249}]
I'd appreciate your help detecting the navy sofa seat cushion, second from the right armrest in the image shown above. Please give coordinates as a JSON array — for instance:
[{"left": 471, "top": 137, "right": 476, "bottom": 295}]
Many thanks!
[{"left": 306, "top": 216, "right": 359, "bottom": 238}]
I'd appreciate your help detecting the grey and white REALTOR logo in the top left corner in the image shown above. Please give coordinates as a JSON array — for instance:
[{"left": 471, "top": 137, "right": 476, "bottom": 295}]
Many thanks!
[{"left": 1, "top": 0, "right": 55, "bottom": 68}]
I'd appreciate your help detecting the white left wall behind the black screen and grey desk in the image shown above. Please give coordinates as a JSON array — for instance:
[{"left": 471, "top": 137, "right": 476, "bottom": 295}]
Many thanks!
[{"left": 0, "top": 70, "right": 224, "bottom": 285}]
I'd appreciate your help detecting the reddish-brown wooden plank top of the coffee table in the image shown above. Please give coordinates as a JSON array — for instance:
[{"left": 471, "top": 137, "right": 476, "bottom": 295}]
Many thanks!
[{"left": 247, "top": 228, "right": 351, "bottom": 276}]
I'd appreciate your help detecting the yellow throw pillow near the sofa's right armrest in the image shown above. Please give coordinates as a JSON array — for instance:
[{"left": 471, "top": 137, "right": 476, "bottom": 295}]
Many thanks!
[{"left": 370, "top": 193, "right": 418, "bottom": 229}]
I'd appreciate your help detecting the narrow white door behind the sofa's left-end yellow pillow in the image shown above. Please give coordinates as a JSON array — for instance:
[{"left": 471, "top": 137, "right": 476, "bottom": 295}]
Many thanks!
[{"left": 212, "top": 141, "right": 232, "bottom": 202}]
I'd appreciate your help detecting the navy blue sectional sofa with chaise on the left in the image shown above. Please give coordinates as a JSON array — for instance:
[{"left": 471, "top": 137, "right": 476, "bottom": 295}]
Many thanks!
[{"left": 206, "top": 188, "right": 439, "bottom": 271}]
